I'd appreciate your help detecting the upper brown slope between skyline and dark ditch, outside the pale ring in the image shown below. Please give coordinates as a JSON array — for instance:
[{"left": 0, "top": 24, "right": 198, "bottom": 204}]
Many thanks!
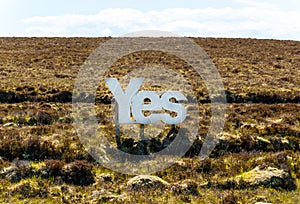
[{"left": 0, "top": 38, "right": 300, "bottom": 103}]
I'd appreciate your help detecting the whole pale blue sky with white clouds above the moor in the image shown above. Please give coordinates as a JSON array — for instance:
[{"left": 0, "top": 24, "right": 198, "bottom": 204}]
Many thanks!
[{"left": 0, "top": 0, "right": 300, "bottom": 41}]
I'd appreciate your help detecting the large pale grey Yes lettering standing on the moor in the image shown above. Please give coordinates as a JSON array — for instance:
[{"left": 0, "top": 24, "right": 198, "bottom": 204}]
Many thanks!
[{"left": 105, "top": 78, "right": 187, "bottom": 124}]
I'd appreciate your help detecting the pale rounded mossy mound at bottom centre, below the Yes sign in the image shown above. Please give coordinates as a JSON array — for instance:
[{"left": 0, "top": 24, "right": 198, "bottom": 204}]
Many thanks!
[{"left": 127, "top": 175, "right": 170, "bottom": 191}]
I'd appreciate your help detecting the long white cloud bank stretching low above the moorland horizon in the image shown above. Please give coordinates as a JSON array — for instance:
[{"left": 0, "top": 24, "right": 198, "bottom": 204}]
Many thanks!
[{"left": 23, "top": 0, "right": 300, "bottom": 40}]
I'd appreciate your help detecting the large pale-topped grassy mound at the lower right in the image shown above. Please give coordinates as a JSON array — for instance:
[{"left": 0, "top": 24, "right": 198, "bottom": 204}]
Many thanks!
[{"left": 219, "top": 166, "right": 297, "bottom": 190}]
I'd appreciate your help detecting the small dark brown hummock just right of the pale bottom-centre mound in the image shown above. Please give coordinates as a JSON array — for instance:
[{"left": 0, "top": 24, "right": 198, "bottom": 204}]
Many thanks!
[{"left": 172, "top": 180, "right": 199, "bottom": 196}]
